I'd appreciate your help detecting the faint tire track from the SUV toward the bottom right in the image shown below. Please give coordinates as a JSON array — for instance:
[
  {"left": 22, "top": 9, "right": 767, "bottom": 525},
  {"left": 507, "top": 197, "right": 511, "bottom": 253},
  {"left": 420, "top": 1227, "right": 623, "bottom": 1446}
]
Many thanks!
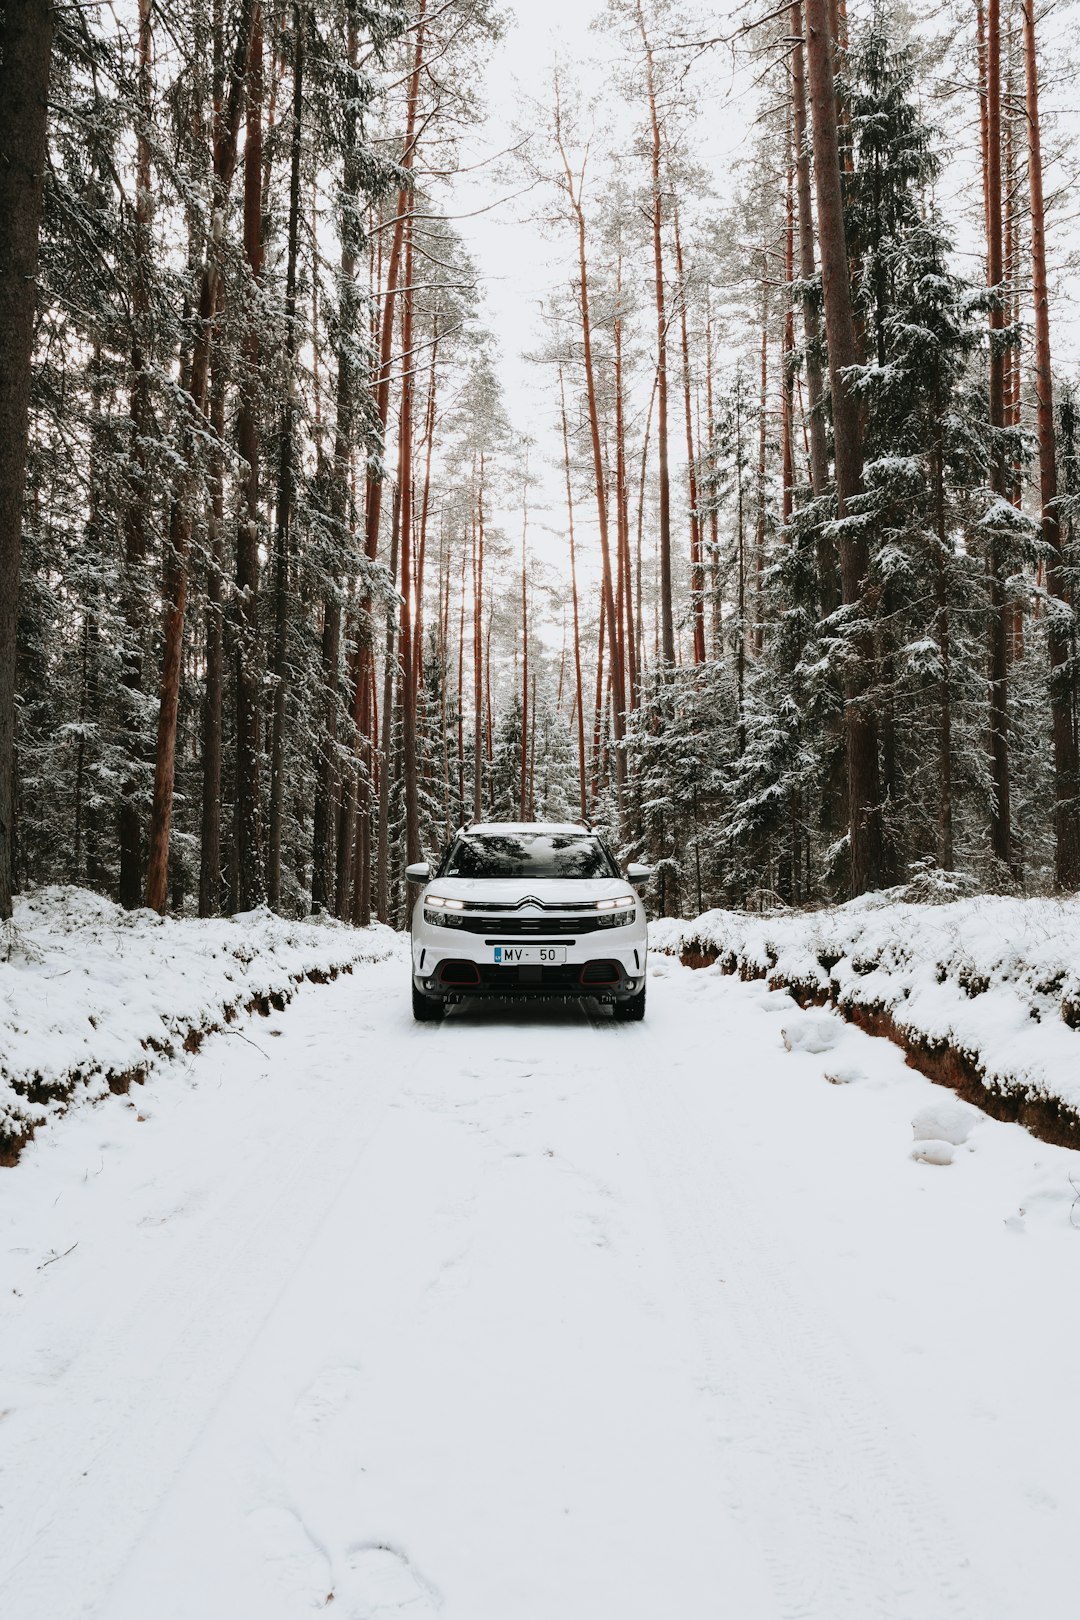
[{"left": 620, "top": 978, "right": 993, "bottom": 1620}]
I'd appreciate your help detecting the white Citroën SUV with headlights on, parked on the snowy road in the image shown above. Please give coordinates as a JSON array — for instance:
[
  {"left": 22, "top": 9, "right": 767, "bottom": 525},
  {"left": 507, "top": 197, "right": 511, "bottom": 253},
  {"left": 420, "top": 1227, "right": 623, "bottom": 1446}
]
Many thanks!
[{"left": 406, "top": 821, "right": 651, "bottom": 1021}]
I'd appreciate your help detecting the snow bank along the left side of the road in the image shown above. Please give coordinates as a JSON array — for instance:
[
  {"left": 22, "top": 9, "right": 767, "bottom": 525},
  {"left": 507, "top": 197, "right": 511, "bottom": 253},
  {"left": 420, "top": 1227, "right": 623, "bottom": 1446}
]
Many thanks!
[{"left": 0, "top": 888, "right": 395, "bottom": 1163}]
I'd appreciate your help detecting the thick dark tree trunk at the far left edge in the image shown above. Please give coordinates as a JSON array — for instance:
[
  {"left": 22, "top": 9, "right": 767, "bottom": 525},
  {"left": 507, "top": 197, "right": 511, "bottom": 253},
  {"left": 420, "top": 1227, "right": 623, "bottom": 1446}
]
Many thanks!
[{"left": 0, "top": 0, "right": 53, "bottom": 920}]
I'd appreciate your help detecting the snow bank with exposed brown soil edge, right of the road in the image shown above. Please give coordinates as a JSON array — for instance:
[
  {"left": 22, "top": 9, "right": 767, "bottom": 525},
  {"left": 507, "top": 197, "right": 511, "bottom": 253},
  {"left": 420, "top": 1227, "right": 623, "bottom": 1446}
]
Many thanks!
[{"left": 649, "top": 894, "right": 1080, "bottom": 1147}]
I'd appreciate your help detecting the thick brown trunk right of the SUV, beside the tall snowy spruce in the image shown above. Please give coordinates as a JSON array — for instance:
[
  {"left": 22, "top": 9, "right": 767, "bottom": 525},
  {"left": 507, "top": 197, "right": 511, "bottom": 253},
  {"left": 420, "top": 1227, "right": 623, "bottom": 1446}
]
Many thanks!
[{"left": 806, "top": 0, "right": 884, "bottom": 894}]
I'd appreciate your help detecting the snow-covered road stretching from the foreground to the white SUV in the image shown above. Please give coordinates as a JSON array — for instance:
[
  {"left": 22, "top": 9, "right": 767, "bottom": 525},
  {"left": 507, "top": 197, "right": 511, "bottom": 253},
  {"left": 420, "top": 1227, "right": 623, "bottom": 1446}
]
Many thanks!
[{"left": 0, "top": 959, "right": 1080, "bottom": 1620}]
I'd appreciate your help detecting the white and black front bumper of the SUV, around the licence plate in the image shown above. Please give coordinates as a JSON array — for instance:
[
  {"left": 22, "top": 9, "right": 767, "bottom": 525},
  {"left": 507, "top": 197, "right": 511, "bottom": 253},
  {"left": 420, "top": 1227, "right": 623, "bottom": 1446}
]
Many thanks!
[{"left": 413, "top": 922, "right": 648, "bottom": 1001}]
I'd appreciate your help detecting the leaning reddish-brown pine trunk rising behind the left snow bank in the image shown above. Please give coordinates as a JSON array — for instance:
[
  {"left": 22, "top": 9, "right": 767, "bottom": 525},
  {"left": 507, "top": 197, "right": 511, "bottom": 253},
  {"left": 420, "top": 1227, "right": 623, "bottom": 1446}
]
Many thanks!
[{"left": 146, "top": 0, "right": 256, "bottom": 912}]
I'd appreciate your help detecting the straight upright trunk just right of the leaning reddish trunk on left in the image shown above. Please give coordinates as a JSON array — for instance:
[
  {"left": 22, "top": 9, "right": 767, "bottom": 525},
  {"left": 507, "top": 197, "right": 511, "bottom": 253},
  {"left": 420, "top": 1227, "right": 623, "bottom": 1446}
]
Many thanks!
[{"left": 235, "top": 0, "right": 266, "bottom": 912}]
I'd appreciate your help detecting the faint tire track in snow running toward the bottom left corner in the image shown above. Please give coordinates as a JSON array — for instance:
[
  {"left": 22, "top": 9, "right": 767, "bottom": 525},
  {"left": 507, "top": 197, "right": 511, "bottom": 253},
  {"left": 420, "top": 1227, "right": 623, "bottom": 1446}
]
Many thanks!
[{"left": 0, "top": 990, "right": 399, "bottom": 1620}]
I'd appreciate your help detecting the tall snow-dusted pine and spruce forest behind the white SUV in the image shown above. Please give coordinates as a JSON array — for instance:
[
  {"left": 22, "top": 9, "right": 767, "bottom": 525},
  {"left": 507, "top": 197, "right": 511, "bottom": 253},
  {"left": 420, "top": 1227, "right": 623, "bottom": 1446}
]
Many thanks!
[{"left": 0, "top": 0, "right": 1080, "bottom": 925}]
